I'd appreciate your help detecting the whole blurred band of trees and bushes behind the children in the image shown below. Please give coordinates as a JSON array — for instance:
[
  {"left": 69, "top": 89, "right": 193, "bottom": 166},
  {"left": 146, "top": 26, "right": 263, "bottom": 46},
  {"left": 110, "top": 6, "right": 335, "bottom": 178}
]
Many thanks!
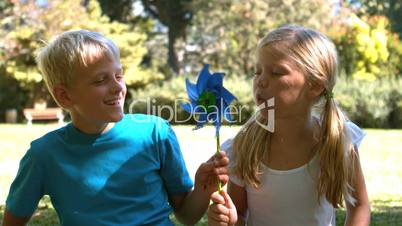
[{"left": 0, "top": 0, "right": 402, "bottom": 127}]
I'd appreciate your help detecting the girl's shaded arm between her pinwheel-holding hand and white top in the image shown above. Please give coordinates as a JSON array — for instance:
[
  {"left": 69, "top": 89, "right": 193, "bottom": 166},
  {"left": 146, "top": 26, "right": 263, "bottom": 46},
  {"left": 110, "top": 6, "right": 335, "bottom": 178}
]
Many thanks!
[{"left": 228, "top": 181, "right": 247, "bottom": 226}]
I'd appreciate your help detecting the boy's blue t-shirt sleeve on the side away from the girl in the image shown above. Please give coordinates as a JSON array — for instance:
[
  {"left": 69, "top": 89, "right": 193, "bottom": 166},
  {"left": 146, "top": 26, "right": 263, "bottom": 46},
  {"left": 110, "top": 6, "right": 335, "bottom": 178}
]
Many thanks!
[{"left": 6, "top": 146, "right": 44, "bottom": 217}]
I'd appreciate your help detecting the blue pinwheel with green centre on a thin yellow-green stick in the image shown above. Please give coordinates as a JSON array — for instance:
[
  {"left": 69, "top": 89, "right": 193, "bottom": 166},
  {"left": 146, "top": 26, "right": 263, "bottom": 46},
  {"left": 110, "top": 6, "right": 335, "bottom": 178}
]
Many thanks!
[{"left": 181, "top": 64, "right": 236, "bottom": 191}]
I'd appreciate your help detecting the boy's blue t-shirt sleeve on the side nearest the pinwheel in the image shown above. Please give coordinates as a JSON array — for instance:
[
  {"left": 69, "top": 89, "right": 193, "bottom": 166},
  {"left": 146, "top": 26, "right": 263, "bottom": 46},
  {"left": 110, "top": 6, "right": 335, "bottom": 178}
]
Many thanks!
[{"left": 160, "top": 122, "right": 193, "bottom": 195}]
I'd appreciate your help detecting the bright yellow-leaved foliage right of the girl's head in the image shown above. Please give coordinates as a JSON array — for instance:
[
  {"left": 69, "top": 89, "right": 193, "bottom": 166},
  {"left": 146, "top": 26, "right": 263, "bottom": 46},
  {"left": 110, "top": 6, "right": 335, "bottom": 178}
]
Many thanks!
[{"left": 330, "top": 14, "right": 402, "bottom": 81}]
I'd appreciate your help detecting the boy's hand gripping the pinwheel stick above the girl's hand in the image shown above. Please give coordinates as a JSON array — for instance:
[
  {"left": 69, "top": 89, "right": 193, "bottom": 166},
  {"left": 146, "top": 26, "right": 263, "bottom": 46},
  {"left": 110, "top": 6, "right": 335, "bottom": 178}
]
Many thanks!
[{"left": 194, "top": 151, "right": 229, "bottom": 193}]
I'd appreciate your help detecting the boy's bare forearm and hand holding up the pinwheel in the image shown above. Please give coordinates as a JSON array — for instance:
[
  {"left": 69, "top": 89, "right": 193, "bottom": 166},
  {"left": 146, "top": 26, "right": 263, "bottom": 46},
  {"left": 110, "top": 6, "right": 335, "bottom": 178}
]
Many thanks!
[{"left": 169, "top": 152, "right": 229, "bottom": 225}]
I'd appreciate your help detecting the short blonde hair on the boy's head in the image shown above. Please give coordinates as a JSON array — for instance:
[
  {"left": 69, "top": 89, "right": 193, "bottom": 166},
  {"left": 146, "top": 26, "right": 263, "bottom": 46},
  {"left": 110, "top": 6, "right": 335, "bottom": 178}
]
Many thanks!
[{"left": 36, "top": 30, "right": 120, "bottom": 105}]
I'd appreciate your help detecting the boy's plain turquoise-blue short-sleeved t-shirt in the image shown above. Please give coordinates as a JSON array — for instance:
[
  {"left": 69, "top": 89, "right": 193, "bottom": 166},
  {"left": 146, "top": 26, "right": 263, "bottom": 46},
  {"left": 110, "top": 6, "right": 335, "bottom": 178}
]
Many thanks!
[{"left": 6, "top": 114, "right": 193, "bottom": 226}]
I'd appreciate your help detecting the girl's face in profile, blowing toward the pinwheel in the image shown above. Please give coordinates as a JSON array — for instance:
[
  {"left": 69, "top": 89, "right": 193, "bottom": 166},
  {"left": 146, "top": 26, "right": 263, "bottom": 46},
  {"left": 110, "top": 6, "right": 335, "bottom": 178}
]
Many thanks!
[{"left": 253, "top": 45, "right": 312, "bottom": 119}]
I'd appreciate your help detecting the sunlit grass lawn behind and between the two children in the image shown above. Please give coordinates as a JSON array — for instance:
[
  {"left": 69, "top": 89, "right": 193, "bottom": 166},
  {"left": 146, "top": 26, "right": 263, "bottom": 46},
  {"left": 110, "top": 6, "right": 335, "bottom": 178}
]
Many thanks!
[{"left": 0, "top": 124, "right": 402, "bottom": 226}]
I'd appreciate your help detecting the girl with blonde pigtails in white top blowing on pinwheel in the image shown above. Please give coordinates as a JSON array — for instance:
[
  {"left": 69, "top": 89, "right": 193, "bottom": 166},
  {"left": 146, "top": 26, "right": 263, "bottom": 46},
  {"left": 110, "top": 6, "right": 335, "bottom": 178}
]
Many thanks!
[{"left": 208, "top": 26, "right": 370, "bottom": 226}]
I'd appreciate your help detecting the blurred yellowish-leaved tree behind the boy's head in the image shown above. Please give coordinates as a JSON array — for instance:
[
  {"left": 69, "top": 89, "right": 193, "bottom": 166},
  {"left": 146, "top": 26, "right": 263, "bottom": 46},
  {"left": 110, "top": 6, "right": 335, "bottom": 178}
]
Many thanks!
[{"left": 0, "top": 0, "right": 163, "bottom": 108}]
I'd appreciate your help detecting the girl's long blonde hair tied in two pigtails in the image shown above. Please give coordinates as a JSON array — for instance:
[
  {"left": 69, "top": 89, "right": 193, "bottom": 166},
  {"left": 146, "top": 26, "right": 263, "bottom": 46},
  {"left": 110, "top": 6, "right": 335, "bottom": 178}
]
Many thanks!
[{"left": 230, "top": 26, "right": 357, "bottom": 207}]
